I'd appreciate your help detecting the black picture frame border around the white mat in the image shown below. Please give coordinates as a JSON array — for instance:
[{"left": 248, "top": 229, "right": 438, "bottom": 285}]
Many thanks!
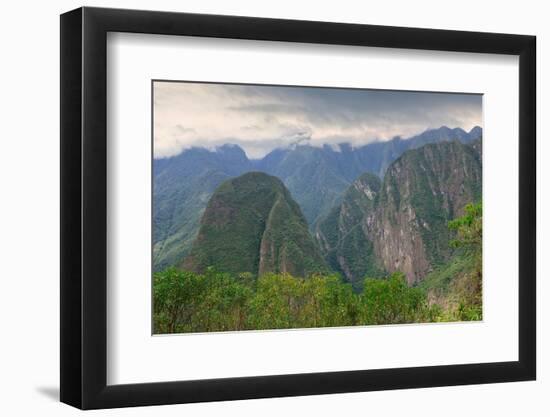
[{"left": 60, "top": 7, "right": 536, "bottom": 409}]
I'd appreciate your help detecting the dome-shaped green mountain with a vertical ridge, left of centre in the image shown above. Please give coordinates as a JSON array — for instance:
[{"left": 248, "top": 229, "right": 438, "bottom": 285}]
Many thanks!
[{"left": 184, "top": 172, "right": 326, "bottom": 277}]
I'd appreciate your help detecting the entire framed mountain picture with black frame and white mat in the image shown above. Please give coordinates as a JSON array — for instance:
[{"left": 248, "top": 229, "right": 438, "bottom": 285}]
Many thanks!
[{"left": 61, "top": 7, "right": 536, "bottom": 409}]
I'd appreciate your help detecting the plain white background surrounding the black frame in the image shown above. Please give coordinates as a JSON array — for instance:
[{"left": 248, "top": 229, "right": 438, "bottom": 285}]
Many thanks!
[{"left": 0, "top": 0, "right": 550, "bottom": 417}]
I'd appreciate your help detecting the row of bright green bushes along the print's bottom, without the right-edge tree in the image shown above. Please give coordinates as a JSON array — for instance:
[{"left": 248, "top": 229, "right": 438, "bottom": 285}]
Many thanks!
[{"left": 154, "top": 268, "right": 439, "bottom": 333}]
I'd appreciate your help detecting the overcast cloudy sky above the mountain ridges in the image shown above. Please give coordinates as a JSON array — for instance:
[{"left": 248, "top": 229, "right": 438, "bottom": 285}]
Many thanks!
[{"left": 154, "top": 82, "right": 482, "bottom": 158}]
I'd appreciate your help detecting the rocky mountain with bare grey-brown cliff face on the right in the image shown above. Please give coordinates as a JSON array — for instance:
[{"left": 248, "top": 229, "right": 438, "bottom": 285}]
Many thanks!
[{"left": 315, "top": 141, "right": 482, "bottom": 285}]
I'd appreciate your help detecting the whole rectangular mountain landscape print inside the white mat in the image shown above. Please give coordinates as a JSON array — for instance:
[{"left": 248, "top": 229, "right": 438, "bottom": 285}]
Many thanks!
[{"left": 152, "top": 80, "right": 483, "bottom": 334}]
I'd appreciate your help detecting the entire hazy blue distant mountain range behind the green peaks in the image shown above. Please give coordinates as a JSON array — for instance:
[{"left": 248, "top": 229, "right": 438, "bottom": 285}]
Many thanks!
[{"left": 153, "top": 126, "right": 482, "bottom": 271}]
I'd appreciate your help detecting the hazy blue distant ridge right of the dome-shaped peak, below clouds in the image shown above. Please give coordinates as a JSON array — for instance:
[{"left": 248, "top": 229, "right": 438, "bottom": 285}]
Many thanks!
[{"left": 256, "top": 126, "right": 482, "bottom": 229}]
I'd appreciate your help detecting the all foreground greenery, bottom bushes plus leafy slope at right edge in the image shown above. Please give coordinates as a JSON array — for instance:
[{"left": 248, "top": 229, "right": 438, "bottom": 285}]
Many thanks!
[{"left": 153, "top": 203, "right": 482, "bottom": 334}]
